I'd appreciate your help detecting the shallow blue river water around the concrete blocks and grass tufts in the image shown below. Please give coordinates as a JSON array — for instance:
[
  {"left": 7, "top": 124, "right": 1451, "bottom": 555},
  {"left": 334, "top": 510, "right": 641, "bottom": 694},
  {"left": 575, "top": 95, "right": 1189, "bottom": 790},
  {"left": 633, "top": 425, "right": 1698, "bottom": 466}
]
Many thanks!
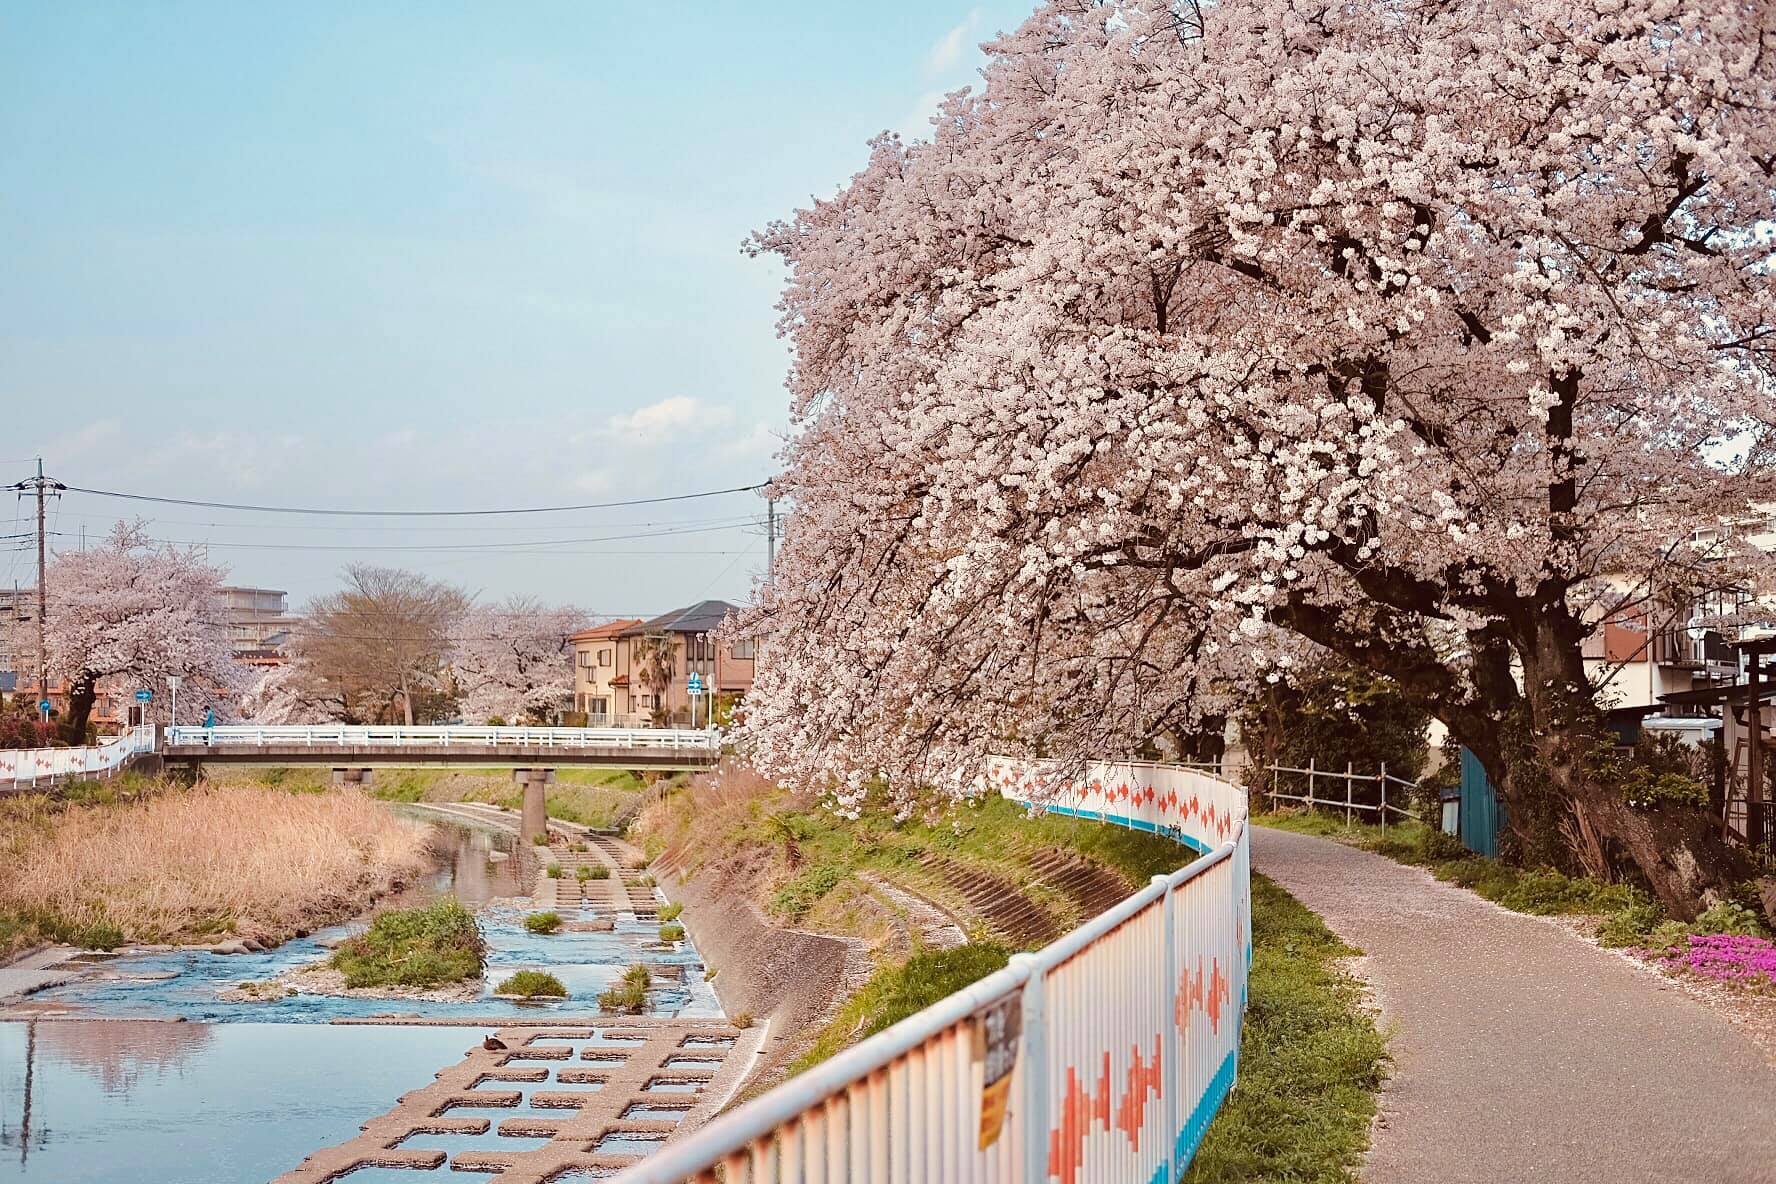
[{"left": 0, "top": 817, "right": 721, "bottom": 1184}]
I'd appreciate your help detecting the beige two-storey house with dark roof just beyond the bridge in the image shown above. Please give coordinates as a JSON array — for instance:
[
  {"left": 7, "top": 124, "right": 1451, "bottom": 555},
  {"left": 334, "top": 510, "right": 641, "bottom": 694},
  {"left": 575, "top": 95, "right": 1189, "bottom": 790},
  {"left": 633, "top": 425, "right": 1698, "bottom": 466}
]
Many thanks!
[{"left": 568, "top": 600, "right": 755, "bottom": 728}]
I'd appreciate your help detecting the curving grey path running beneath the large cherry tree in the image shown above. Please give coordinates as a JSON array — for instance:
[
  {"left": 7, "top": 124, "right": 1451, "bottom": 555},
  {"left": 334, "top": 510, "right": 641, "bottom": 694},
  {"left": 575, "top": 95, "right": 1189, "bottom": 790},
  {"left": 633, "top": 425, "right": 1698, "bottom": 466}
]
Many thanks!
[{"left": 1252, "top": 827, "right": 1776, "bottom": 1184}]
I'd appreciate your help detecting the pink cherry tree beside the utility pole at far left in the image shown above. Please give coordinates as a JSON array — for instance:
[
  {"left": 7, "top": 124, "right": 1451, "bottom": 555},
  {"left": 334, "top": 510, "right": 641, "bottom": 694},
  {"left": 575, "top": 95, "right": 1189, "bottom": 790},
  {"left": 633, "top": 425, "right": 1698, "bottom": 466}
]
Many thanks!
[{"left": 44, "top": 522, "right": 243, "bottom": 742}]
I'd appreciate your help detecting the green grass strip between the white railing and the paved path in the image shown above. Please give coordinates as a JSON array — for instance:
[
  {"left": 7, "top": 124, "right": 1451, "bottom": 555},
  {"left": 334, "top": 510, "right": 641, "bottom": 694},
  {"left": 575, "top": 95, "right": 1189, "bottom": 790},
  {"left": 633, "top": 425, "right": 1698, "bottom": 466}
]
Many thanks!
[{"left": 1185, "top": 873, "right": 1387, "bottom": 1184}]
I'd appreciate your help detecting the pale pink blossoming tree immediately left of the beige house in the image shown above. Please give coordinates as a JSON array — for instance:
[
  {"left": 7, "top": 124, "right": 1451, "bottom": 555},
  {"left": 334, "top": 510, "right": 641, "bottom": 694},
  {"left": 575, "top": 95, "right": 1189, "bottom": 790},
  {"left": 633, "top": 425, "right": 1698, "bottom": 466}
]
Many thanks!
[{"left": 449, "top": 596, "right": 586, "bottom": 721}]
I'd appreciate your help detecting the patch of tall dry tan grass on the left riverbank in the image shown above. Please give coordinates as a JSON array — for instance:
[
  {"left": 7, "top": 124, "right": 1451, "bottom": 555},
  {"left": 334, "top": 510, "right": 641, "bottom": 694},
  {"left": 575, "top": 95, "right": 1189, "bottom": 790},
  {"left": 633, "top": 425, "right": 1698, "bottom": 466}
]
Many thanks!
[{"left": 0, "top": 786, "right": 430, "bottom": 941}]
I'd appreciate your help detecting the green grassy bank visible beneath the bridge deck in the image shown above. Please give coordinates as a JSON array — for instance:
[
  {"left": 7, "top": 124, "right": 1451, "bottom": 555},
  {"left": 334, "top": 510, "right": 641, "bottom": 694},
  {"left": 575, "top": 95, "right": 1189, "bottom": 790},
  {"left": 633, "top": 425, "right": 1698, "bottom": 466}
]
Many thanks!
[{"left": 218, "top": 767, "right": 667, "bottom": 827}]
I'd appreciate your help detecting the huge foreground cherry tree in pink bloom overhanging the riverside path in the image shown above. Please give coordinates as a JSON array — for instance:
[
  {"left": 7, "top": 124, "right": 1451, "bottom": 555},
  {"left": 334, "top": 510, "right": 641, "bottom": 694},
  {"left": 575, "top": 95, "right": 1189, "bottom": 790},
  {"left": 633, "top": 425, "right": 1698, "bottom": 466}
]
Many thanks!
[{"left": 742, "top": 0, "right": 1776, "bottom": 914}]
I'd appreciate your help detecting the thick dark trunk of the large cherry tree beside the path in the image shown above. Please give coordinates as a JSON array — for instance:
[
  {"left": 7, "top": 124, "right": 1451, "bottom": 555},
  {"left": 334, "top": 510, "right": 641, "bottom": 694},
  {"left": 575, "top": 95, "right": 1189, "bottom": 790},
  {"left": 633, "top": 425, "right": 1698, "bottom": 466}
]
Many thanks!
[{"left": 1476, "top": 614, "right": 1751, "bottom": 920}]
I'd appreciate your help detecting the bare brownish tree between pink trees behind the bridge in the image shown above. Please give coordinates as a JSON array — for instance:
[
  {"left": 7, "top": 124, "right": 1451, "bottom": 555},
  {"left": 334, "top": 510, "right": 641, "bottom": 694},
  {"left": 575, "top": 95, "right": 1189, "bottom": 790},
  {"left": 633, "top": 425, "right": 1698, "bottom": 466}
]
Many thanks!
[{"left": 297, "top": 564, "right": 469, "bottom": 724}]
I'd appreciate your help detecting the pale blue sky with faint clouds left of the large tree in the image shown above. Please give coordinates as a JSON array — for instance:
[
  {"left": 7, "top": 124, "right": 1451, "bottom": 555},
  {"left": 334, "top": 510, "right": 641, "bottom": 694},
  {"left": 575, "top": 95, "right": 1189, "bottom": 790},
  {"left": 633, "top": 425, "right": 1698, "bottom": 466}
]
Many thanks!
[{"left": 0, "top": 0, "right": 1034, "bottom": 614}]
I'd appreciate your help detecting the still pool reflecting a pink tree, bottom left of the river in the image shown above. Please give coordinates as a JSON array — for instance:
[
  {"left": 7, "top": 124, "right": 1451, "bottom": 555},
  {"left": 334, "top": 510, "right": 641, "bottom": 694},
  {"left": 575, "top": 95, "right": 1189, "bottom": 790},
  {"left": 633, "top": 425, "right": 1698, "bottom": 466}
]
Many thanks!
[{"left": 0, "top": 1021, "right": 485, "bottom": 1184}]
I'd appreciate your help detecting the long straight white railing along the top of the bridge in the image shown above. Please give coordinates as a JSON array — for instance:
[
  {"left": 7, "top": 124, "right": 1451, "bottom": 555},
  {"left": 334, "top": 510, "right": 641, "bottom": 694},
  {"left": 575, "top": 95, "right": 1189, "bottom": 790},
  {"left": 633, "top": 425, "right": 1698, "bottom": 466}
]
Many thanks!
[{"left": 167, "top": 724, "right": 721, "bottom": 749}]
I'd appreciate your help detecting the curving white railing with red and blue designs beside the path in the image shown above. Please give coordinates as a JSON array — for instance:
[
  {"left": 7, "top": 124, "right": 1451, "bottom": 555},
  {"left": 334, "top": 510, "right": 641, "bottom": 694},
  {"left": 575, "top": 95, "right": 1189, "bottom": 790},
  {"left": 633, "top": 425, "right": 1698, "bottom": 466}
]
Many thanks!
[{"left": 616, "top": 762, "right": 1252, "bottom": 1184}]
